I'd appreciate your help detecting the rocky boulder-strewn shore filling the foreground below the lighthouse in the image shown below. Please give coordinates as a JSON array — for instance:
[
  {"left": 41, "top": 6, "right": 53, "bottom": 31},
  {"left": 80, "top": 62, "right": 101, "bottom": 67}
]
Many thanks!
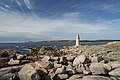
[{"left": 0, "top": 42, "right": 120, "bottom": 80}]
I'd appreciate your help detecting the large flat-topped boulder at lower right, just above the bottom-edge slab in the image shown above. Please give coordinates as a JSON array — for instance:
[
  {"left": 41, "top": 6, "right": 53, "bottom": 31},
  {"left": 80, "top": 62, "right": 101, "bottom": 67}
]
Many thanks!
[{"left": 90, "top": 63, "right": 109, "bottom": 75}]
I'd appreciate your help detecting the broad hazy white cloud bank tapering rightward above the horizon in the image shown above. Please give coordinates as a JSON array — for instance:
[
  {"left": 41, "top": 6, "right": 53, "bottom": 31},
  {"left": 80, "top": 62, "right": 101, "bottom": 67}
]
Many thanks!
[{"left": 0, "top": 11, "right": 106, "bottom": 39}]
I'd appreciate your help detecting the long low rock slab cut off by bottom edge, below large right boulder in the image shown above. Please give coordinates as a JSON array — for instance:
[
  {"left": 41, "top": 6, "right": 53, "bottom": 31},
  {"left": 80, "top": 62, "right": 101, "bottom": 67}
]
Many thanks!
[{"left": 82, "top": 76, "right": 112, "bottom": 80}]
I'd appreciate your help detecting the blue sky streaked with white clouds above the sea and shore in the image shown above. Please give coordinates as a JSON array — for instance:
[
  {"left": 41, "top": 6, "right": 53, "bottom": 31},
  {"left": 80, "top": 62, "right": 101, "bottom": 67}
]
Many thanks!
[{"left": 0, "top": 0, "right": 120, "bottom": 43}]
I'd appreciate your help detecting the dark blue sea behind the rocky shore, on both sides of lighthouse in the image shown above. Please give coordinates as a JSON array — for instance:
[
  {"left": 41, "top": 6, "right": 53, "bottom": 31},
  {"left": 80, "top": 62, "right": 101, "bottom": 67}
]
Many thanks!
[{"left": 0, "top": 41, "right": 107, "bottom": 53}]
